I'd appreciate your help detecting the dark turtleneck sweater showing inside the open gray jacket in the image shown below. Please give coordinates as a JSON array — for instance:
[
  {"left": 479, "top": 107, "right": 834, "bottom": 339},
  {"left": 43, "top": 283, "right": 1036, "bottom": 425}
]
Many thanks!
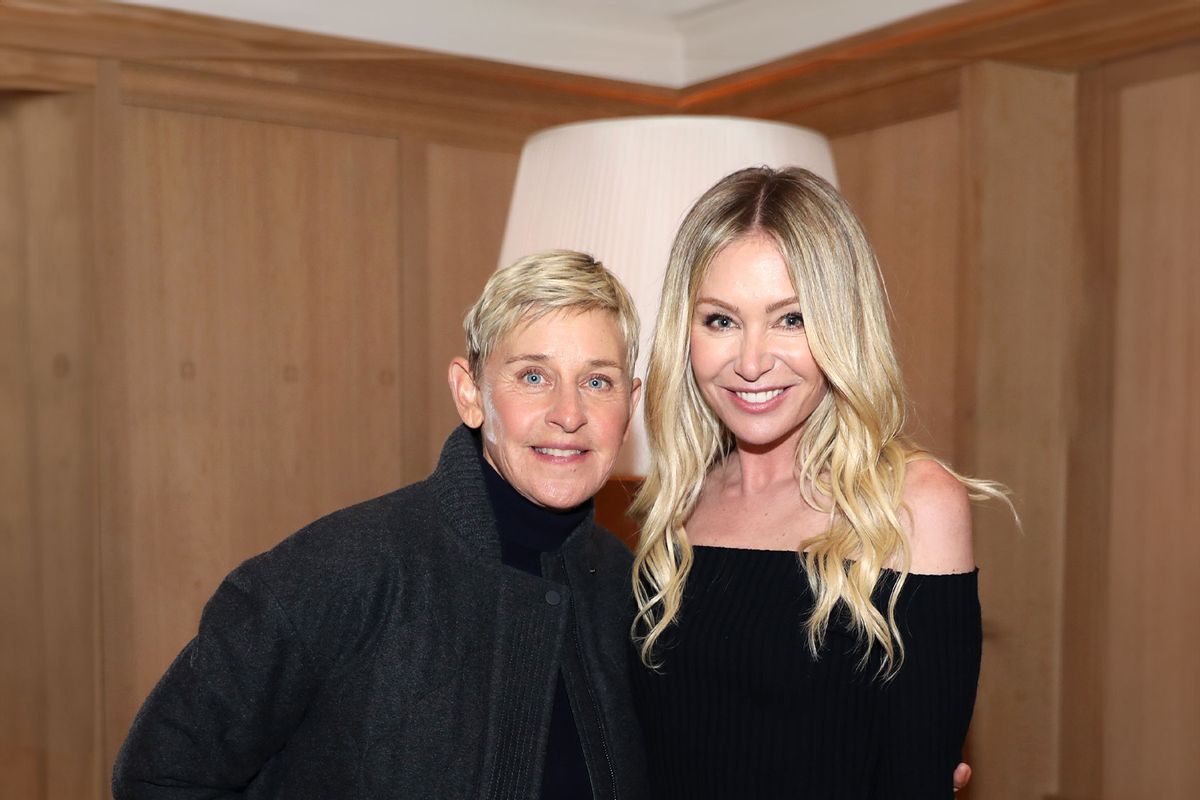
[{"left": 484, "top": 461, "right": 592, "bottom": 800}]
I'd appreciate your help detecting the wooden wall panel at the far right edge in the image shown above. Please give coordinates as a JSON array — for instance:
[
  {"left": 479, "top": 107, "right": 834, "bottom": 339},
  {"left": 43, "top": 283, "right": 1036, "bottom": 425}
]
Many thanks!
[{"left": 1102, "top": 72, "right": 1200, "bottom": 800}]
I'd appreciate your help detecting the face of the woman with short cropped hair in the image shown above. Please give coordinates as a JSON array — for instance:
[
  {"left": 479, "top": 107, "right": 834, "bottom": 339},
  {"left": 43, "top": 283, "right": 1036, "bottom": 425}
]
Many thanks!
[{"left": 464, "top": 309, "right": 640, "bottom": 509}]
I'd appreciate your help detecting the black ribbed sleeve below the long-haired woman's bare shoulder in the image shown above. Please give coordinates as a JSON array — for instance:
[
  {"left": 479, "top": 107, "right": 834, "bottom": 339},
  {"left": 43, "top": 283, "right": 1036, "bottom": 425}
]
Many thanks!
[{"left": 875, "top": 572, "right": 983, "bottom": 800}]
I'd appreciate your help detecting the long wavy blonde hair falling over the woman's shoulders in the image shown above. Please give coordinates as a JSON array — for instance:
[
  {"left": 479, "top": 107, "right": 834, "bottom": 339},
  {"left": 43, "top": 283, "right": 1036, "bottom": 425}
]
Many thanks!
[{"left": 632, "top": 167, "right": 1004, "bottom": 675}]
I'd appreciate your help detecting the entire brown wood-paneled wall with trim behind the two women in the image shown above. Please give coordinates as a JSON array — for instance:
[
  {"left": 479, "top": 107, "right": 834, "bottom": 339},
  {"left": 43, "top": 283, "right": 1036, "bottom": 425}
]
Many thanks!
[{"left": 0, "top": 0, "right": 1200, "bottom": 800}]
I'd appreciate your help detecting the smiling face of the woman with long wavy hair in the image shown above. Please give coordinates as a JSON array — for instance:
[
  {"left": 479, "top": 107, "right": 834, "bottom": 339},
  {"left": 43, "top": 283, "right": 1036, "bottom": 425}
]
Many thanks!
[{"left": 691, "top": 234, "right": 827, "bottom": 449}]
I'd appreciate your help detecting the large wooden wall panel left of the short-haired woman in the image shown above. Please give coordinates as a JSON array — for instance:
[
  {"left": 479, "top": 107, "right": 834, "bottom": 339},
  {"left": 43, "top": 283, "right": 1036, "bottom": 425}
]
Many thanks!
[{"left": 97, "top": 108, "right": 401, "bottom": 758}]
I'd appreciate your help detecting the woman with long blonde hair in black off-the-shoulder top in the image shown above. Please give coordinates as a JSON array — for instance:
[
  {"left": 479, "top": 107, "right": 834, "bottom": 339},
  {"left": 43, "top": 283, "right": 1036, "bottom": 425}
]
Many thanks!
[{"left": 634, "top": 168, "right": 1003, "bottom": 800}]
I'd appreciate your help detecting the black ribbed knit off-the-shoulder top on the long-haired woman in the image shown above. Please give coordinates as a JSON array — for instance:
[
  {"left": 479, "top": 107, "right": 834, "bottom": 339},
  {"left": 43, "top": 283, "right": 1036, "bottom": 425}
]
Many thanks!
[{"left": 634, "top": 547, "right": 982, "bottom": 800}]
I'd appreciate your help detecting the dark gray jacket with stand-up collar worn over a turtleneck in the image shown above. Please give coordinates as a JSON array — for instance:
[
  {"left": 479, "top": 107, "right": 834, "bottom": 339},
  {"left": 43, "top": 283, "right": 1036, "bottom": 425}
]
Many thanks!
[{"left": 113, "top": 428, "right": 646, "bottom": 800}]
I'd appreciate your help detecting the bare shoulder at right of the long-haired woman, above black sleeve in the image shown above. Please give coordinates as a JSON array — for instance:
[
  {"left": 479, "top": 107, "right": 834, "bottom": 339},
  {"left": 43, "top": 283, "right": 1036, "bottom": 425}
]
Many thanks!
[{"left": 901, "top": 459, "right": 974, "bottom": 575}]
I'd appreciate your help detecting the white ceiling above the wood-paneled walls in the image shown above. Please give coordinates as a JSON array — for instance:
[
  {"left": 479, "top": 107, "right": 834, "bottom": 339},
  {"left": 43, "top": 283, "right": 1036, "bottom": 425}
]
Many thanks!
[{"left": 118, "top": 0, "right": 961, "bottom": 89}]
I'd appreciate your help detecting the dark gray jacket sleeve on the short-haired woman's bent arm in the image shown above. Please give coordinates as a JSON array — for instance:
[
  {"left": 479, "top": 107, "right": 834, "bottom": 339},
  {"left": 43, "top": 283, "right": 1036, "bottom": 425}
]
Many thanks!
[{"left": 113, "top": 565, "right": 317, "bottom": 800}]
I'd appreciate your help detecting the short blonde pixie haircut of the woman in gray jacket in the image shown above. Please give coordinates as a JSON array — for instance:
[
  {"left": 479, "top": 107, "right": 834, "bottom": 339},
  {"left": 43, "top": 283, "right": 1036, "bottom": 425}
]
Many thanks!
[{"left": 462, "top": 249, "right": 638, "bottom": 380}]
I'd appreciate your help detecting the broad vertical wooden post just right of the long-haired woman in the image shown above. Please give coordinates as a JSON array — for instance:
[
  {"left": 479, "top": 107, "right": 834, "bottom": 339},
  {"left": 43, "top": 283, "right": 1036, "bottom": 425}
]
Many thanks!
[{"left": 961, "top": 64, "right": 1081, "bottom": 800}]
